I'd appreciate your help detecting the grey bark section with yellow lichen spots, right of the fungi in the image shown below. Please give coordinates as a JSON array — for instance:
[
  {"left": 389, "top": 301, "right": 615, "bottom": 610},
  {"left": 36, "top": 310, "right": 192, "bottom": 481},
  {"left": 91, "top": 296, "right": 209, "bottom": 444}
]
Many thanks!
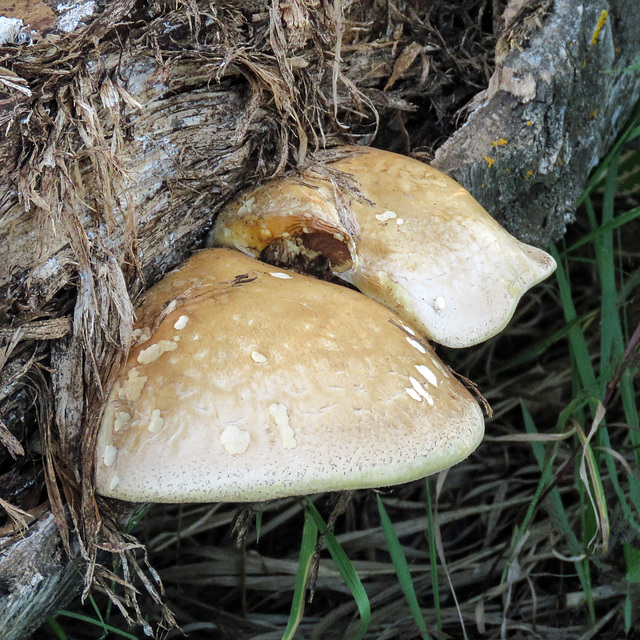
[{"left": 434, "top": 0, "right": 640, "bottom": 246}]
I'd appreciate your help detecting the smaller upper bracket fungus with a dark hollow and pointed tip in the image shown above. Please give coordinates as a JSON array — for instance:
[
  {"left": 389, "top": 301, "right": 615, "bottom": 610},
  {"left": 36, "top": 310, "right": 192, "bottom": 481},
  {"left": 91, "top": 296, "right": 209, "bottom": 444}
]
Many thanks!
[{"left": 209, "top": 147, "right": 555, "bottom": 347}]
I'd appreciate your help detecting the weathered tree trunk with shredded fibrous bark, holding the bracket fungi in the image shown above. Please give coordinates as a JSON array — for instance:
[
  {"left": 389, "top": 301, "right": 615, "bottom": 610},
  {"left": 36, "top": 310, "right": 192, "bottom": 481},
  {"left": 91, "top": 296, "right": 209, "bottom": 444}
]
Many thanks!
[{"left": 0, "top": 0, "right": 640, "bottom": 640}]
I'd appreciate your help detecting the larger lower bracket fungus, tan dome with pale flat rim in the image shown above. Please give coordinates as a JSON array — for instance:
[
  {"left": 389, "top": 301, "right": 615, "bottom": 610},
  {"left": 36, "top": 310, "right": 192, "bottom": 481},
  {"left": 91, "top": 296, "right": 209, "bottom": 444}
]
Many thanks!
[{"left": 96, "top": 249, "right": 484, "bottom": 502}]
